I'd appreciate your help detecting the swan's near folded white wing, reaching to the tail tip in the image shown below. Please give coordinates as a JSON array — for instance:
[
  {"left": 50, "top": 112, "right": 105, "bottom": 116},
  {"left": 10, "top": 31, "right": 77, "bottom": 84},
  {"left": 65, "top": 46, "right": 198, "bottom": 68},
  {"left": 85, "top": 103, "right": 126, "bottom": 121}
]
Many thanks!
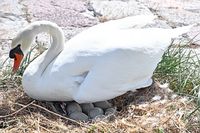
[{"left": 70, "top": 26, "right": 192, "bottom": 103}]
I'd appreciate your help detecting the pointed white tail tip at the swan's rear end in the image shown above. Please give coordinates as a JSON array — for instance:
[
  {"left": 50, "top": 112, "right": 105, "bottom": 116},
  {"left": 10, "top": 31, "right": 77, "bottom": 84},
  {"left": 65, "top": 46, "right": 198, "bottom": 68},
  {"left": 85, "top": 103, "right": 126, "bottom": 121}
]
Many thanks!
[{"left": 171, "top": 24, "right": 195, "bottom": 38}]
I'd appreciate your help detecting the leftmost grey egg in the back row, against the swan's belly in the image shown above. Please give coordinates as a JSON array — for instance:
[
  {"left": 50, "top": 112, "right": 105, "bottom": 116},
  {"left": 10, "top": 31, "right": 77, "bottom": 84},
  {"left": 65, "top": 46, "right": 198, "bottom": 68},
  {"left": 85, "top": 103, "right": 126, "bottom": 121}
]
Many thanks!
[{"left": 66, "top": 102, "right": 82, "bottom": 114}]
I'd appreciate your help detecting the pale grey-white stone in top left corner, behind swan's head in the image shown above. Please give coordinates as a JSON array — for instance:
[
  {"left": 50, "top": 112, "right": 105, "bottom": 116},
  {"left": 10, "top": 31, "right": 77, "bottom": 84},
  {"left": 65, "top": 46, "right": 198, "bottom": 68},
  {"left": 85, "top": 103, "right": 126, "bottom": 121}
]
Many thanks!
[{"left": 0, "top": 0, "right": 27, "bottom": 39}]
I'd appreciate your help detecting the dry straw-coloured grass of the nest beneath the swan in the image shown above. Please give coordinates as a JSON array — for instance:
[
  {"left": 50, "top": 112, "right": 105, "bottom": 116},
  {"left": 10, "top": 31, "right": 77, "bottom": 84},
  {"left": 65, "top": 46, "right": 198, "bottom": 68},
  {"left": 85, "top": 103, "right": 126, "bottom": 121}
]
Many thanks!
[{"left": 0, "top": 77, "right": 200, "bottom": 133}]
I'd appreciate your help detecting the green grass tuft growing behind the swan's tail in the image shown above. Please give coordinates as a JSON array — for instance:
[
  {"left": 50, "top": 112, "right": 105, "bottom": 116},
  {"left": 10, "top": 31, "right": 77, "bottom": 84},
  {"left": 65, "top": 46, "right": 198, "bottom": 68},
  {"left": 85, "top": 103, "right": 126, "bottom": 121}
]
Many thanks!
[{"left": 154, "top": 40, "right": 200, "bottom": 116}]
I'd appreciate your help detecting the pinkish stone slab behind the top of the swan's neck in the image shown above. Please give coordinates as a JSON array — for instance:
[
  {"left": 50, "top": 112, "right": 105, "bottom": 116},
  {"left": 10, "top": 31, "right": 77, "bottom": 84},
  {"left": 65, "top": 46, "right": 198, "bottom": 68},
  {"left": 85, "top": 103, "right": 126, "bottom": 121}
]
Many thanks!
[{"left": 22, "top": 0, "right": 98, "bottom": 27}]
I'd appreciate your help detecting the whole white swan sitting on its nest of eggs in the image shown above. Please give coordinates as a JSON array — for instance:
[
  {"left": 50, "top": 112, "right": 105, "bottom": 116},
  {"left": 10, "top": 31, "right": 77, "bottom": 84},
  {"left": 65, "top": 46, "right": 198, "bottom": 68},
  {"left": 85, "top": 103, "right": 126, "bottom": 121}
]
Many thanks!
[{"left": 9, "top": 15, "right": 192, "bottom": 103}]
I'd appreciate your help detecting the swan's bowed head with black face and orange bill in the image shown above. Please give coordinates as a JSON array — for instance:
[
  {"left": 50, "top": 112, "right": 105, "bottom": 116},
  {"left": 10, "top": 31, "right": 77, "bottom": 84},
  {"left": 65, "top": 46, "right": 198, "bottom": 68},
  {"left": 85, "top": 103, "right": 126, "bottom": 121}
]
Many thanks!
[{"left": 9, "top": 28, "right": 34, "bottom": 72}]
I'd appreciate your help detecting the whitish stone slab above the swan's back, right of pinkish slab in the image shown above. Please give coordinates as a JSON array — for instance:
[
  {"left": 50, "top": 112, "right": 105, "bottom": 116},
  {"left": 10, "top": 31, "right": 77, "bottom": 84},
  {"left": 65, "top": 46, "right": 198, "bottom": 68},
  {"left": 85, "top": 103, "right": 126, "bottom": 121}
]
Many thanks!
[{"left": 90, "top": 0, "right": 152, "bottom": 21}]
